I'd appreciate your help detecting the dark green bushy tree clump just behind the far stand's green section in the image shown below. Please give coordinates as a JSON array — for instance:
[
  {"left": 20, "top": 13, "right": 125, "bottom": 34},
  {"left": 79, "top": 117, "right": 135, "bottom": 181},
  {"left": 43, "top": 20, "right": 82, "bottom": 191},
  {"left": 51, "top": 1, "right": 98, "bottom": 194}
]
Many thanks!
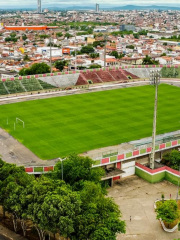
[{"left": 19, "top": 63, "right": 50, "bottom": 76}]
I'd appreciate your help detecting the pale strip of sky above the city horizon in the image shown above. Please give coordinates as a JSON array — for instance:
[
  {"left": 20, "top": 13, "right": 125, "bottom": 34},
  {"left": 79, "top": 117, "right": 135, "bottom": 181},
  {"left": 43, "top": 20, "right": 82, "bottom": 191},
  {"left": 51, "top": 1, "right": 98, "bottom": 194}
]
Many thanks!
[{"left": 0, "top": 0, "right": 180, "bottom": 9}]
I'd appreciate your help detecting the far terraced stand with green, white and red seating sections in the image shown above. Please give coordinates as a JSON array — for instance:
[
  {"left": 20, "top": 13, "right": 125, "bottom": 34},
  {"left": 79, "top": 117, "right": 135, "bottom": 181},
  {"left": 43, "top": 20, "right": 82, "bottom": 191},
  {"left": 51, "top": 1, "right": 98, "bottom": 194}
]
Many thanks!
[{"left": 0, "top": 69, "right": 143, "bottom": 95}]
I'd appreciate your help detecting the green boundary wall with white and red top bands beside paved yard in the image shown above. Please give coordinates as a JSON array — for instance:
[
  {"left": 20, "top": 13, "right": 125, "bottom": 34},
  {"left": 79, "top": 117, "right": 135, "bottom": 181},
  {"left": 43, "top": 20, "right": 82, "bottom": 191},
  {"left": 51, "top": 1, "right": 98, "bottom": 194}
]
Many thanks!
[{"left": 135, "top": 163, "right": 180, "bottom": 185}]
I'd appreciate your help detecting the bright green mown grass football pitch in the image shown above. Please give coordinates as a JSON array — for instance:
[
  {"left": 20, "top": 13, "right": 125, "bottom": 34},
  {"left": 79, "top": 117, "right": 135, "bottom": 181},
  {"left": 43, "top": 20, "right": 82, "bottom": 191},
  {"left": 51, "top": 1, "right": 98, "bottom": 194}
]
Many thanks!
[{"left": 0, "top": 84, "right": 180, "bottom": 159}]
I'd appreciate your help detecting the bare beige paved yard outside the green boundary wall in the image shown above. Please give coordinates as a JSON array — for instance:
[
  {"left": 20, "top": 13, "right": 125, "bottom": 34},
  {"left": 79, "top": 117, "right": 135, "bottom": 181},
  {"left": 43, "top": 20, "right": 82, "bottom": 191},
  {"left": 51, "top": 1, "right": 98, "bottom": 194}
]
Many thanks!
[{"left": 108, "top": 176, "right": 180, "bottom": 240}]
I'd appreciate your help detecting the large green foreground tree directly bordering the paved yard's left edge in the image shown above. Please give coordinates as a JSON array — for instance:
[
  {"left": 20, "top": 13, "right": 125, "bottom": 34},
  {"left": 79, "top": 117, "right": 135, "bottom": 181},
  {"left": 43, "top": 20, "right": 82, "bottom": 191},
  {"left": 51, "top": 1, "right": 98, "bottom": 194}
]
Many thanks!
[{"left": 72, "top": 181, "right": 125, "bottom": 240}]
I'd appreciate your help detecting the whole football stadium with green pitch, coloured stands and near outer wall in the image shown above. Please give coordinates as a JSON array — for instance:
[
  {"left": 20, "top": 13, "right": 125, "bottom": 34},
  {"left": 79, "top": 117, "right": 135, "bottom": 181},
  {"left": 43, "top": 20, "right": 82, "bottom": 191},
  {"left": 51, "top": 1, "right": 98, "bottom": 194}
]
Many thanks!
[{"left": 0, "top": 66, "right": 180, "bottom": 184}]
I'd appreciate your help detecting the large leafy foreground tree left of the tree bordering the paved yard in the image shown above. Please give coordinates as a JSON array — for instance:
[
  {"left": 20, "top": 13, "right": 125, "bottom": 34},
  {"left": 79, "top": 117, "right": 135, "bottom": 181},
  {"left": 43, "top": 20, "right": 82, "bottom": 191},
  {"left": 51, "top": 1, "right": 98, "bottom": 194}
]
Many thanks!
[{"left": 27, "top": 176, "right": 81, "bottom": 240}]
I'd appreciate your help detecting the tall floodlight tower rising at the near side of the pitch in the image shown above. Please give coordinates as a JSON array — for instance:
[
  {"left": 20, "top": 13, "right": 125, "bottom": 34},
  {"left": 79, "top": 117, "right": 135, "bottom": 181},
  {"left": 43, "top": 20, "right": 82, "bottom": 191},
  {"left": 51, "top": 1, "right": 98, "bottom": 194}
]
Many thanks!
[{"left": 150, "top": 70, "right": 160, "bottom": 169}]
